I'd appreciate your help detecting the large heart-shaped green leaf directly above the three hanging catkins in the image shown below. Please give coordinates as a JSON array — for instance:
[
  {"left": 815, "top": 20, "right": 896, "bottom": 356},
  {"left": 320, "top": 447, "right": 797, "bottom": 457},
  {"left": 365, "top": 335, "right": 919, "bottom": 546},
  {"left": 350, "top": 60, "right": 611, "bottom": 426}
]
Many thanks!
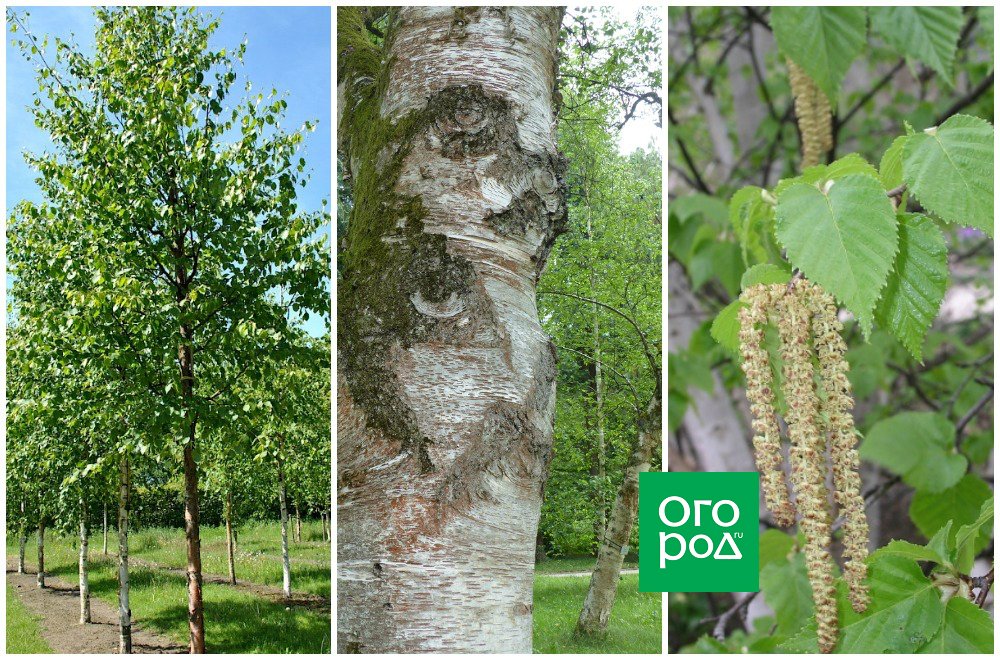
[{"left": 776, "top": 174, "right": 898, "bottom": 336}]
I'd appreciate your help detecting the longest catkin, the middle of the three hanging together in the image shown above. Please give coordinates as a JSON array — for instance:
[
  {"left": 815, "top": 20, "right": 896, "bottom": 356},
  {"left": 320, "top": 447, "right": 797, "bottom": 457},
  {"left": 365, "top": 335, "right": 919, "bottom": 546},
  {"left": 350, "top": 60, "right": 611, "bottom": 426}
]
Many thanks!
[{"left": 774, "top": 291, "right": 837, "bottom": 653}]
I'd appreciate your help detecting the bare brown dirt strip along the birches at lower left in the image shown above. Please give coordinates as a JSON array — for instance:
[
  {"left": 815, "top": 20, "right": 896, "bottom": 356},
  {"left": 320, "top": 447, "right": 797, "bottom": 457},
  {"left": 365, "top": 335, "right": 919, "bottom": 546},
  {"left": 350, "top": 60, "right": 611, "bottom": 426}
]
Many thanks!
[{"left": 7, "top": 564, "right": 187, "bottom": 653}]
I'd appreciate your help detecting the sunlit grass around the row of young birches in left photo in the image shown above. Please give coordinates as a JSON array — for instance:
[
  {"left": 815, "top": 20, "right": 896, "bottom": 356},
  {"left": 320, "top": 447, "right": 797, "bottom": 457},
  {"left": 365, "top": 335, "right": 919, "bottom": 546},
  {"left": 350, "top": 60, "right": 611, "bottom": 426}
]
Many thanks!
[{"left": 8, "top": 522, "right": 330, "bottom": 653}]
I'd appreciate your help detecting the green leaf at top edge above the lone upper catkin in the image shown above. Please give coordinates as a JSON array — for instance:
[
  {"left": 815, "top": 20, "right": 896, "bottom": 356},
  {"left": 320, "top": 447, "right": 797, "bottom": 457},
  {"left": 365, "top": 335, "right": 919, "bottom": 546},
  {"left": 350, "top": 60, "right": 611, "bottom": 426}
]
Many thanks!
[{"left": 771, "top": 6, "right": 866, "bottom": 105}]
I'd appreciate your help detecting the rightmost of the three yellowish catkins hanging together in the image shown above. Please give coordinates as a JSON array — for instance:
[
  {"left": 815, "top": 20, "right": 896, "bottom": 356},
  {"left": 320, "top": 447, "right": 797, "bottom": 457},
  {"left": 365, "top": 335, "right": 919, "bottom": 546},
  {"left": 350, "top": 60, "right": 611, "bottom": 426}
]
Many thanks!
[{"left": 803, "top": 283, "right": 869, "bottom": 612}]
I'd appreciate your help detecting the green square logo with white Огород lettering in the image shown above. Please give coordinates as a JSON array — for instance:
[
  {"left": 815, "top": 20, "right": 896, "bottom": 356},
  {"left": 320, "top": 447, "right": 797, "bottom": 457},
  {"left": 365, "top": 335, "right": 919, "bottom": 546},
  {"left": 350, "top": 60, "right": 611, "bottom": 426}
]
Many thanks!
[{"left": 639, "top": 472, "right": 760, "bottom": 592}]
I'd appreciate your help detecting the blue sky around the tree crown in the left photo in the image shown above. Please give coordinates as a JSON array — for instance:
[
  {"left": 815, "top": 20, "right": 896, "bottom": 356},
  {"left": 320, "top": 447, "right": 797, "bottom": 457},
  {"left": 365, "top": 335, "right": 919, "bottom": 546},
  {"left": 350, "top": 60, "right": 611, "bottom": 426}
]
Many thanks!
[{"left": 6, "top": 7, "right": 333, "bottom": 335}]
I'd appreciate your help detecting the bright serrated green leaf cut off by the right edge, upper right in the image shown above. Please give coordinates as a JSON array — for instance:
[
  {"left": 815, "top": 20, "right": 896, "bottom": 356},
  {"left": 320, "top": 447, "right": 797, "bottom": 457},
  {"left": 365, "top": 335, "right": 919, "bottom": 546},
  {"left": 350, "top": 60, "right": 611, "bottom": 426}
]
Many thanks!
[{"left": 903, "top": 115, "right": 993, "bottom": 237}]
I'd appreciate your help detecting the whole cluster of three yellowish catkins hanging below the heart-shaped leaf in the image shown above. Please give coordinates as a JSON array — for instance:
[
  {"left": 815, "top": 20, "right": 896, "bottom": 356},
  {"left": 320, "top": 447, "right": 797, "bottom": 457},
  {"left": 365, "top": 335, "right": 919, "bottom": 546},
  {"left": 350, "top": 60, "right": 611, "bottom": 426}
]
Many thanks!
[{"left": 739, "top": 279, "right": 869, "bottom": 653}]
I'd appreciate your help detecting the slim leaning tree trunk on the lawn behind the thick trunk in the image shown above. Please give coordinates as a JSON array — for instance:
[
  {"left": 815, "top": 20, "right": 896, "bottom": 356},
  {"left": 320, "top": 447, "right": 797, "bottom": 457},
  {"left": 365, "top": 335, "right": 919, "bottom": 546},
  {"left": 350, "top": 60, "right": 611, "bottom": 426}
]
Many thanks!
[{"left": 576, "top": 392, "right": 662, "bottom": 635}]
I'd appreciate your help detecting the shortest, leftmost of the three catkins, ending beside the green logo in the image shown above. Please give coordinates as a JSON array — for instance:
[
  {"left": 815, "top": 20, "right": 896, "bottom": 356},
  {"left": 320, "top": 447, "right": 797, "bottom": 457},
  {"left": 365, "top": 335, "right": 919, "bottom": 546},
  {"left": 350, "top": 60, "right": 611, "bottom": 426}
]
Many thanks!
[{"left": 740, "top": 285, "right": 795, "bottom": 527}]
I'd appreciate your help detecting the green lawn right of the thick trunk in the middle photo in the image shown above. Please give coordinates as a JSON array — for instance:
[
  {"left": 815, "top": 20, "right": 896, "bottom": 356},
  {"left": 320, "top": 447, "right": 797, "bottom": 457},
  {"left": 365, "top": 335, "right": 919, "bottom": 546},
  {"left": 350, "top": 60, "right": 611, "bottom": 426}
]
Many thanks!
[{"left": 533, "top": 572, "right": 662, "bottom": 653}]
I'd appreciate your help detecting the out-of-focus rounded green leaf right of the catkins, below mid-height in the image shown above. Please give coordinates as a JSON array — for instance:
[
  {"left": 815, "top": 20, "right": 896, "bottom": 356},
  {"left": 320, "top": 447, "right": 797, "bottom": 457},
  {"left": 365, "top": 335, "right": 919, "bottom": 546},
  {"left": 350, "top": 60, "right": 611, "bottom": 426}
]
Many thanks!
[{"left": 861, "top": 412, "right": 969, "bottom": 493}]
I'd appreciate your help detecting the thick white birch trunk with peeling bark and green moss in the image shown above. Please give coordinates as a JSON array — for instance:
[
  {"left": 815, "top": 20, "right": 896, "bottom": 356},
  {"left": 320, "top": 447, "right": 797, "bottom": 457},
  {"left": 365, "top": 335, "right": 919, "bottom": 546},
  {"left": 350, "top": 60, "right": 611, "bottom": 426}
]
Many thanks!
[{"left": 337, "top": 7, "right": 566, "bottom": 653}]
